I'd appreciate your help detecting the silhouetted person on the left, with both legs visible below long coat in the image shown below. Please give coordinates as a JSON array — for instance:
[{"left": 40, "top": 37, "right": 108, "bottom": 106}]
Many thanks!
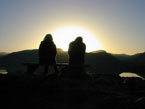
[{"left": 39, "top": 34, "right": 58, "bottom": 74}]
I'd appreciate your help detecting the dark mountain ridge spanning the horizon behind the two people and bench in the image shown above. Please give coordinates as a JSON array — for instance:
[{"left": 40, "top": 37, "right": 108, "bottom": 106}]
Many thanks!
[{"left": 0, "top": 48, "right": 145, "bottom": 74}]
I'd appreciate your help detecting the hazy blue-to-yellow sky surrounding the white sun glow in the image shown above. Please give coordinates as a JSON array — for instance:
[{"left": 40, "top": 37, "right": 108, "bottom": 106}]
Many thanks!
[{"left": 0, "top": 0, "right": 145, "bottom": 54}]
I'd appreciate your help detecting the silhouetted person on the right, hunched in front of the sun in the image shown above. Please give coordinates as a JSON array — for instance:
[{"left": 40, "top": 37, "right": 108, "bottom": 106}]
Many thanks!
[{"left": 68, "top": 37, "right": 86, "bottom": 65}]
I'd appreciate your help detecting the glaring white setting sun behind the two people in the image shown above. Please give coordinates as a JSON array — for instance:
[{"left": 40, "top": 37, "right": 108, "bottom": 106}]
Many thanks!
[{"left": 52, "top": 27, "right": 103, "bottom": 52}]
